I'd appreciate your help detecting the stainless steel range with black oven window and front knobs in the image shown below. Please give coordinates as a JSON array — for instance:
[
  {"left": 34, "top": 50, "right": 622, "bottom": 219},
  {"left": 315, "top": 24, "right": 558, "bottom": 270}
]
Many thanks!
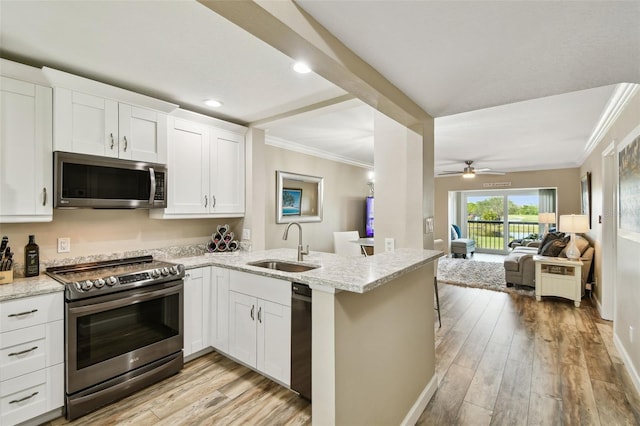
[{"left": 46, "top": 256, "right": 184, "bottom": 420}]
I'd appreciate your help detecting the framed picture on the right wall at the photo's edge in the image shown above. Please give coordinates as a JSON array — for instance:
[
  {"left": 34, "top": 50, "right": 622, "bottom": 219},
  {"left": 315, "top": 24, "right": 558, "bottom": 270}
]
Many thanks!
[{"left": 618, "top": 126, "right": 640, "bottom": 242}]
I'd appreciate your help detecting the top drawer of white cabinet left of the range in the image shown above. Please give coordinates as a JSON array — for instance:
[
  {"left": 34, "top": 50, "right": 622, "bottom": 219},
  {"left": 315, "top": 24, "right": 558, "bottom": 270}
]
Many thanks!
[{"left": 0, "top": 292, "right": 64, "bottom": 333}]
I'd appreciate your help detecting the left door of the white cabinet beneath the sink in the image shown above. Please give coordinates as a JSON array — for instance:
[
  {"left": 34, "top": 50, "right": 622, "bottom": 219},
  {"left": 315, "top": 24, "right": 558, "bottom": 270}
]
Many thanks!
[{"left": 229, "top": 291, "right": 258, "bottom": 367}]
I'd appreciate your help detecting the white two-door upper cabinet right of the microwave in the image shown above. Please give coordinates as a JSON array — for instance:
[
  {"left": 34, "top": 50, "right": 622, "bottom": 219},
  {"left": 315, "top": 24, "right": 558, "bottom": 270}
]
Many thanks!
[{"left": 150, "top": 111, "right": 245, "bottom": 219}]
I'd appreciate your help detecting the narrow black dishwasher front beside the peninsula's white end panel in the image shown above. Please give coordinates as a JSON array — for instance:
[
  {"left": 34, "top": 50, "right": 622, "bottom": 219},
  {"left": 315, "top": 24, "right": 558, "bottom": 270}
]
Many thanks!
[{"left": 291, "top": 283, "right": 311, "bottom": 401}]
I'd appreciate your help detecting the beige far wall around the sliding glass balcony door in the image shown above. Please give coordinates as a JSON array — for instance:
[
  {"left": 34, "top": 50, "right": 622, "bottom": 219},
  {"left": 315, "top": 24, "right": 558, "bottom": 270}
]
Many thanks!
[{"left": 434, "top": 168, "right": 580, "bottom": 246}]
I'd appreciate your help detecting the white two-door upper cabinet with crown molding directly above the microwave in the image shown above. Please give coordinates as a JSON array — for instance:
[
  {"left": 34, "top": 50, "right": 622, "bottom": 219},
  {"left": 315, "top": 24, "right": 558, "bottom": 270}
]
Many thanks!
[{"left": 44, "top": 67, "right": 177, "bottom": 164}]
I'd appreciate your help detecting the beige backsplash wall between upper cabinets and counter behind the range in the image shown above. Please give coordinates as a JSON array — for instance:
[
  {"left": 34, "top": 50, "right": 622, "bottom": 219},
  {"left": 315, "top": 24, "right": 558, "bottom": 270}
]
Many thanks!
[{"left": 0, "top": 209, "right": 242, "bottom": 270}]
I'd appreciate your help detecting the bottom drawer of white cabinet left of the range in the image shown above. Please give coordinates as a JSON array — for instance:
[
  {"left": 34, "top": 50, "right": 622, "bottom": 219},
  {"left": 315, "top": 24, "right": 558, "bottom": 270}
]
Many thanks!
[{"left": 0, "top": 364, "right": 64, "bottom": 425}]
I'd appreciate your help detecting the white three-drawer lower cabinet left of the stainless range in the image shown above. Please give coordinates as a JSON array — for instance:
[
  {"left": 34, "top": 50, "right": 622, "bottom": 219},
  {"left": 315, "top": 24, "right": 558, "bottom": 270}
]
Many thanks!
[{"left": 0, "top": 292, "right": 64, "bottom": 425}]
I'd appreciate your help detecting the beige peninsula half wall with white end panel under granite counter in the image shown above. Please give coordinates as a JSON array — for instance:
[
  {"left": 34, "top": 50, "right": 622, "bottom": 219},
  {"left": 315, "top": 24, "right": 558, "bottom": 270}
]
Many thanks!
[{"left": 312, "top": 263, "right": 435, "bottom": 425}]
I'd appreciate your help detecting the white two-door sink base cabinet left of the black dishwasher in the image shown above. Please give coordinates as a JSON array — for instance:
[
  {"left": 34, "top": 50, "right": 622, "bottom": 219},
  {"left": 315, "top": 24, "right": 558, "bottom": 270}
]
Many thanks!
[{"left": 229, "top": 271, "right": 291, "bottom": 385}]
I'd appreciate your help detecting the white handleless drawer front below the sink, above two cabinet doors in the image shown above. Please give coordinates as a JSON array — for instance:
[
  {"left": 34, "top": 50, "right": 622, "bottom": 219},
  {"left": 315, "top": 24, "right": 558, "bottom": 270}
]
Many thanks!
[{"left": 229, "top": 271, "right": 291, "bottom": 306}]
